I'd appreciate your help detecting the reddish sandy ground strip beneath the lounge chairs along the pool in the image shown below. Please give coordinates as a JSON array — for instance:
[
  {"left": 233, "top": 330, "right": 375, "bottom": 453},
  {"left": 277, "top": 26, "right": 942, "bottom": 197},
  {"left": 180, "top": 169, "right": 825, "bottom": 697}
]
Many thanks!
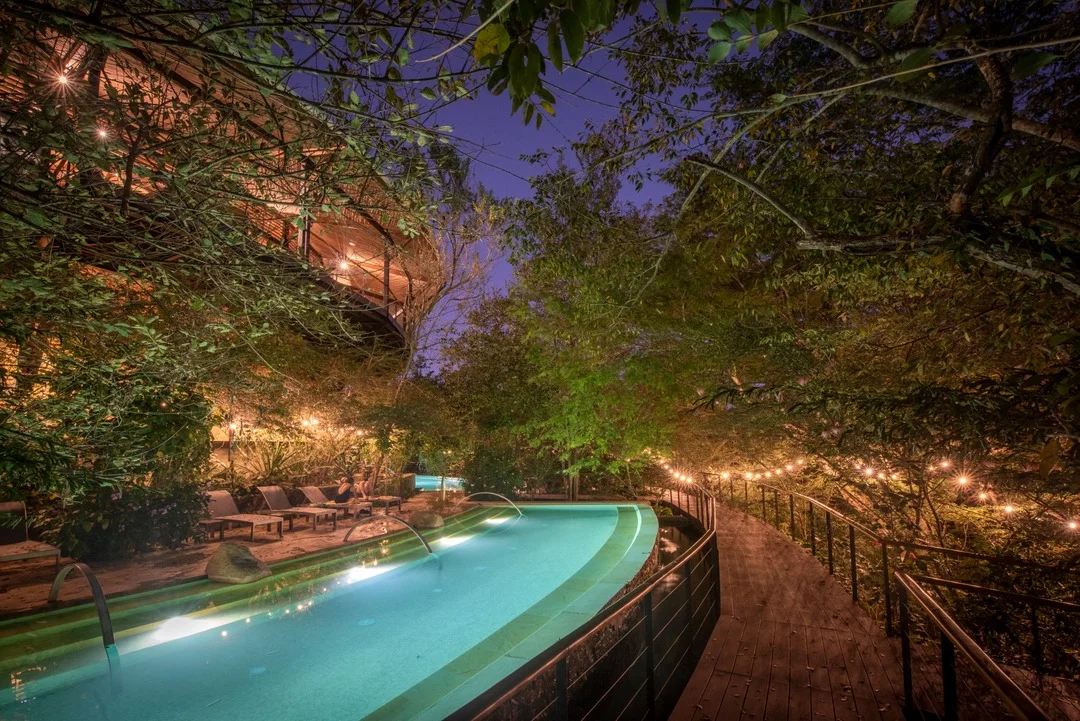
[{"left": 0, "top": 493, "right": 468, "bottom": 617}]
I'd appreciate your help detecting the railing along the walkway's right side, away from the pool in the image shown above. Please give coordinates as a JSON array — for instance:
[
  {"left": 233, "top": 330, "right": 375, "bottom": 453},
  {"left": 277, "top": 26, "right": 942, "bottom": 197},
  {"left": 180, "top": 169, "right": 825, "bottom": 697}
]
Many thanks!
[{"left": 716, "top": 479, "right": 1080, "bottom": 721}]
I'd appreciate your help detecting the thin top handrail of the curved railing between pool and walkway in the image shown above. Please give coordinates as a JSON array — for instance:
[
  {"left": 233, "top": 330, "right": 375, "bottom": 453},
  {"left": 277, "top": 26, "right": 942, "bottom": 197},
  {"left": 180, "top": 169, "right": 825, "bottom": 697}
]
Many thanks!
[{"left": 444, "top": 474, "right": 719, "bottom": 721}]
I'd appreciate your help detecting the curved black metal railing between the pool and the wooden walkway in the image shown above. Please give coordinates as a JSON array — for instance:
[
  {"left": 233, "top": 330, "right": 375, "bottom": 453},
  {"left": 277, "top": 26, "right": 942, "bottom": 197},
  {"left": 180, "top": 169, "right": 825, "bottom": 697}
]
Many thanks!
[{"left": 448, "top": 482, "right": 720, "bottom": 721}]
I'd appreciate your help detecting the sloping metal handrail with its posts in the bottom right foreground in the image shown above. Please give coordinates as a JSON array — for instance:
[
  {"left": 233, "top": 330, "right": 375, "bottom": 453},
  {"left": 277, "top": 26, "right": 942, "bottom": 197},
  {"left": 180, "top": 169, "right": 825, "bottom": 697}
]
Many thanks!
[{"left": 895, "top": 571, "right": 1050, "bottom": 721}]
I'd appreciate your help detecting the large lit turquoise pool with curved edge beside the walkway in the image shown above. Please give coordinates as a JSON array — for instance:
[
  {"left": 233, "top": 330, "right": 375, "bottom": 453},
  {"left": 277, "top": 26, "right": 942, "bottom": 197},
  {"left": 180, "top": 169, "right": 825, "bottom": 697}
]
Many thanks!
[{"left": 0, "top": 504, "right": 657, "bottom": 721}]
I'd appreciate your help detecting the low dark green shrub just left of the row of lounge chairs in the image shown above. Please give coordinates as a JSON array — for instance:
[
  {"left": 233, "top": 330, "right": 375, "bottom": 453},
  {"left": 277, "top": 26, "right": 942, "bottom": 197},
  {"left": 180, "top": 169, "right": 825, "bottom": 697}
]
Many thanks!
[{"left": 32, "top": 480, "right": 206, "bottom": 561}]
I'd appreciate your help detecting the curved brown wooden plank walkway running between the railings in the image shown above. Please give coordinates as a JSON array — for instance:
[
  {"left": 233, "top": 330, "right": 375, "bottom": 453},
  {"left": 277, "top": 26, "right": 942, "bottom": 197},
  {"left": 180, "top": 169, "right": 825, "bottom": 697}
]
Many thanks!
[{"left": 671, "top": 504, "right": 924, "bottom": 721}]
